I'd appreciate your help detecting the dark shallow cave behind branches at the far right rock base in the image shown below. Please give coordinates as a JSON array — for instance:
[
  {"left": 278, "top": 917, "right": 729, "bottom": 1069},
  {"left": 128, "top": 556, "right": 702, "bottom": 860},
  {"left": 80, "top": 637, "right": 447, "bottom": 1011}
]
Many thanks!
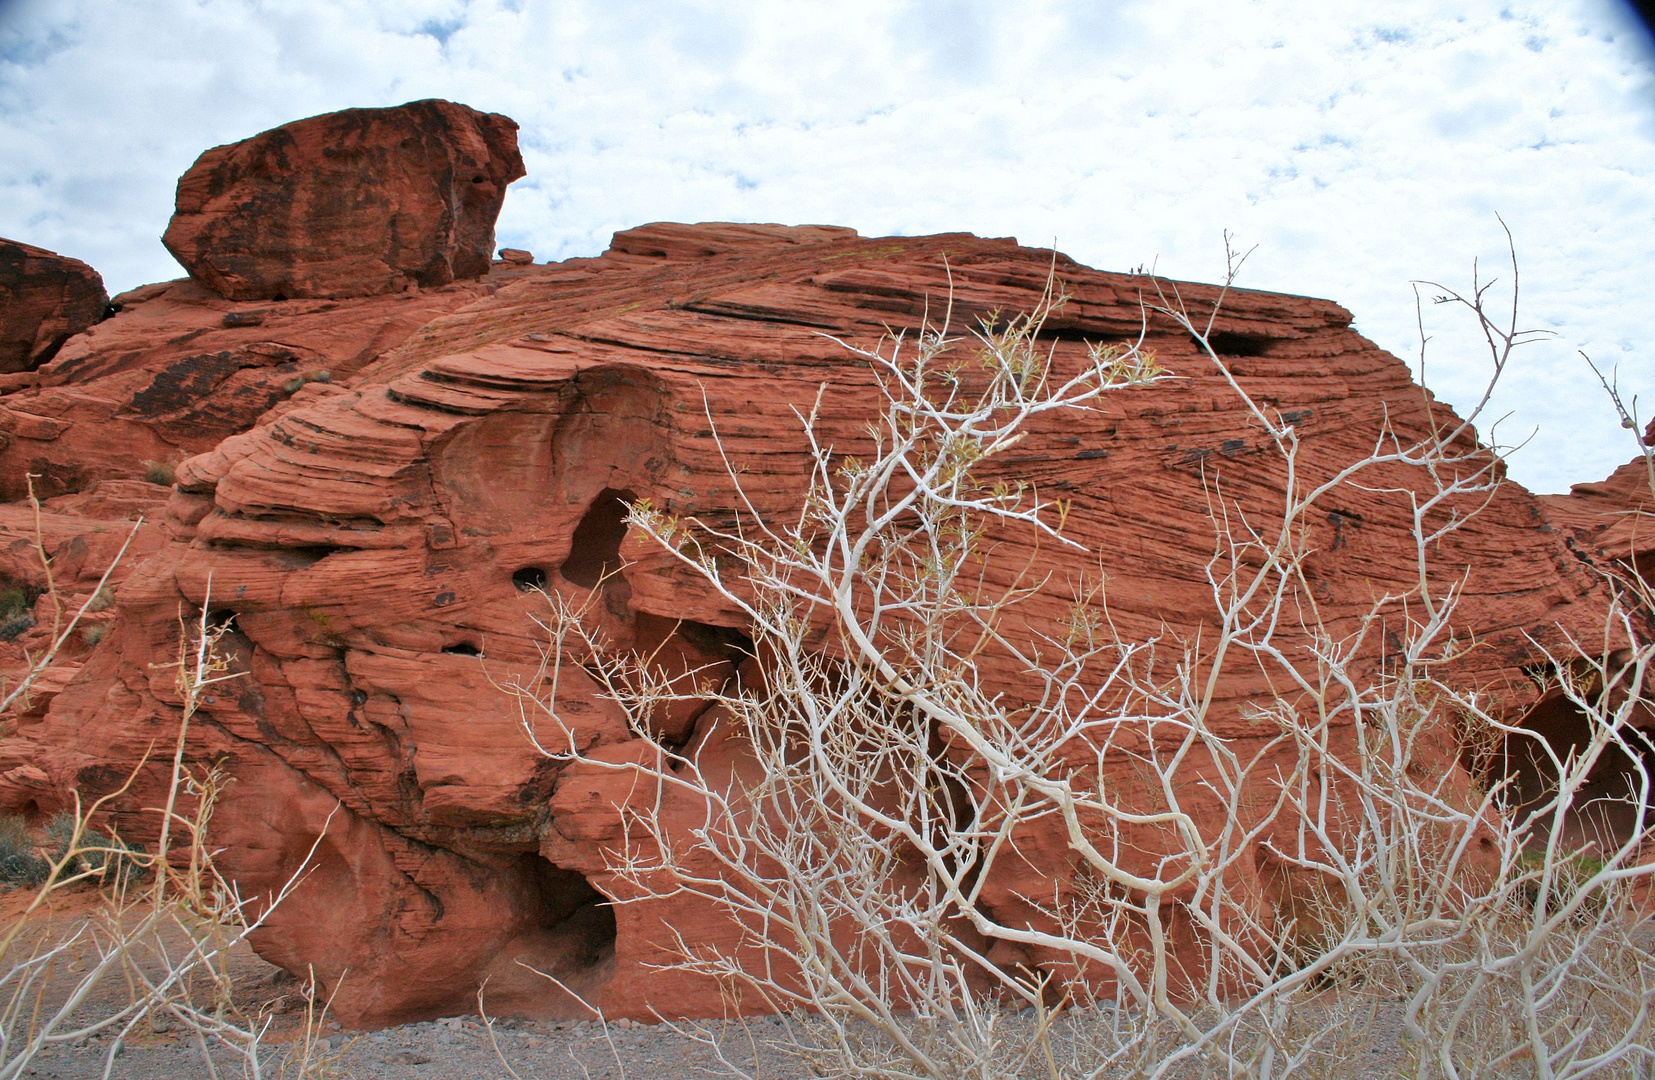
[{"left": 1493, "top": 693, "right": 1655, "bottom": 852}]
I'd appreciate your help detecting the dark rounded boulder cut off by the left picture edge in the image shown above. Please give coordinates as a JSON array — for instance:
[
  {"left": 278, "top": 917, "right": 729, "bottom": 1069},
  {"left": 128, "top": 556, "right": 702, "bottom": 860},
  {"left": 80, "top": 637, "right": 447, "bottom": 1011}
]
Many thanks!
[{"left": 0, "top": 237, "right": 109, "bottom": 374}]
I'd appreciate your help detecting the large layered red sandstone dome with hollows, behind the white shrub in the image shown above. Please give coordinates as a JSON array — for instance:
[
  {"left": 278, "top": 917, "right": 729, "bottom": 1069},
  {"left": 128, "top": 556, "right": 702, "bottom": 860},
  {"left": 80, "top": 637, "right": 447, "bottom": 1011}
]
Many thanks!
[{"left": 0, "top": 225, "right": 1602, "bottom": 1024}]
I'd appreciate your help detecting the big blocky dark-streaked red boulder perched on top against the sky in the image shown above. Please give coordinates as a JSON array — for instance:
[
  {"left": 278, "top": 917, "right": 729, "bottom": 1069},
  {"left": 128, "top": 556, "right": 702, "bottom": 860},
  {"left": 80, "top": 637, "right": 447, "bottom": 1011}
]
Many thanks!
[{"left": 162, "top": 99, "right": 523, "bottom": 299}]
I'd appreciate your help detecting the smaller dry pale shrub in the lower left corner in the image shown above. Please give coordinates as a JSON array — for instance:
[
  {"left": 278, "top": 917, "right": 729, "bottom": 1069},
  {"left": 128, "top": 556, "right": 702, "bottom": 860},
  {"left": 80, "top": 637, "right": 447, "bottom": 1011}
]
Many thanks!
[{"left": 0, "top": 598, "right": 336, "bottom": 1080}]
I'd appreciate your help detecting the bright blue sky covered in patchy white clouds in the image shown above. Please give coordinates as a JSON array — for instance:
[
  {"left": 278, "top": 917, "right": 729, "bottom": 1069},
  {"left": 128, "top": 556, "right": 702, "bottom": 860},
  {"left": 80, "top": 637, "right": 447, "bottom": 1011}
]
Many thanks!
[{"left": 0, "top": 0, "right": 1655, "bottom": 491}]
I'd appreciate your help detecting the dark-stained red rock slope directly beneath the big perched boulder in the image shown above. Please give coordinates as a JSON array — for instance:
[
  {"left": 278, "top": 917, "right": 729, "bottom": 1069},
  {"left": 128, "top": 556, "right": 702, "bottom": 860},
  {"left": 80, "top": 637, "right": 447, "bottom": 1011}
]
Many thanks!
[{"left": 0, "top": 263, "right": 546, "bottom": 499}]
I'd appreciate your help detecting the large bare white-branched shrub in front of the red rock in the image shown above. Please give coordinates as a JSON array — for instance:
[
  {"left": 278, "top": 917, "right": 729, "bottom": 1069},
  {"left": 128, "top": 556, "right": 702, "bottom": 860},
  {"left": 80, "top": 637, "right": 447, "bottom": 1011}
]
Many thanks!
[{"left": 515, "top": 246, "right": 1655, "bottom": 1080}]
